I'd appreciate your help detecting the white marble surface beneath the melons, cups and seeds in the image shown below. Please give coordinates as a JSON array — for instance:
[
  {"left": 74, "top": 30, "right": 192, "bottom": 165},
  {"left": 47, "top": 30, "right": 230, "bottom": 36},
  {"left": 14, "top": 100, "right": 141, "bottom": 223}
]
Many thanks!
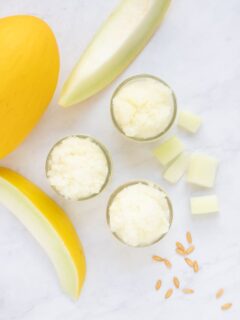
[{"left": 0, "top": 0, "right": 240, "bottom": 320}]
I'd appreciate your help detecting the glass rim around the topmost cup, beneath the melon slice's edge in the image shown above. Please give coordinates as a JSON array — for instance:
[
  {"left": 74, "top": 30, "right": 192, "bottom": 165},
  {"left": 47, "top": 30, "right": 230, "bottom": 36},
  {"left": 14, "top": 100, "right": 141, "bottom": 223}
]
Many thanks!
[{"left": 110, "top": 73, "right": 177, "bottom": 142}]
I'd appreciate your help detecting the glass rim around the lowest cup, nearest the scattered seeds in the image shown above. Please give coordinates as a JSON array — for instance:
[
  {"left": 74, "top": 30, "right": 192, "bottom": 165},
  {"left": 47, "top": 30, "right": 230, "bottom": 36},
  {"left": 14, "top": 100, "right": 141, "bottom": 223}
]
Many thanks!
[{"left": 106, "top": 180, "right": 173, "bottom": 248}]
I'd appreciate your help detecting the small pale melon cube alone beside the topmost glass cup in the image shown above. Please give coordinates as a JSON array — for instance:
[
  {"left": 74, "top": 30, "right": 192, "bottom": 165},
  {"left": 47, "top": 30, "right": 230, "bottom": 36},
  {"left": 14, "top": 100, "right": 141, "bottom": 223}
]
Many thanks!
[{"left": 178, "top": 111, "right": 202, "bottom": 133}]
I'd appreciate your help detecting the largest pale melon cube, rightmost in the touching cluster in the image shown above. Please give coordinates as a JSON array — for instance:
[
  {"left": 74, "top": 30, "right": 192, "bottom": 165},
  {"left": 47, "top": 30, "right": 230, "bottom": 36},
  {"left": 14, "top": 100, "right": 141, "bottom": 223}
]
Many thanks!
[{"left": 187, "top": 154, "right": 218, "bottom": 188}]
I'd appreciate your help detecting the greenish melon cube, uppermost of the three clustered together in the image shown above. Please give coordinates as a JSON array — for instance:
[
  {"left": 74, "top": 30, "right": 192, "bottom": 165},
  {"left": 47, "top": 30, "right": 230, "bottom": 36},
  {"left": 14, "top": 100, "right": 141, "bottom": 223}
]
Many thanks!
[{"left": 154, "top": 136, "right": 184, "bottom": 166}]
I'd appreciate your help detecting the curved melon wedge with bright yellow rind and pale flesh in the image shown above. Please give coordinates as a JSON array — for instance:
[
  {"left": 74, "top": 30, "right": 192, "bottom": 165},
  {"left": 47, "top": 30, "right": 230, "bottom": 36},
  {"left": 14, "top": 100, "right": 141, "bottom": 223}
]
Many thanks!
[{"left": 0, "top": 168, "right": 86, "bottom": 299}]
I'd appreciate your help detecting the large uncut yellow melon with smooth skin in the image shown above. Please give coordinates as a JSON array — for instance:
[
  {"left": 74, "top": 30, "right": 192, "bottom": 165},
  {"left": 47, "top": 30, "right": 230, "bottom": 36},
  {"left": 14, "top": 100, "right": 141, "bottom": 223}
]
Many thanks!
[{"left": 0, "top": 15, "right": 60, "bottom": 158}]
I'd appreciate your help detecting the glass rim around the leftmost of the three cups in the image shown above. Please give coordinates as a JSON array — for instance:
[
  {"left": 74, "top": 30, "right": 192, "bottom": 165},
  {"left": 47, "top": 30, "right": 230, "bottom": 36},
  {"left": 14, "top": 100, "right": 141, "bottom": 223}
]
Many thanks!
[{"left": 45, "top": 134, "right": 112, "bottom": 201}]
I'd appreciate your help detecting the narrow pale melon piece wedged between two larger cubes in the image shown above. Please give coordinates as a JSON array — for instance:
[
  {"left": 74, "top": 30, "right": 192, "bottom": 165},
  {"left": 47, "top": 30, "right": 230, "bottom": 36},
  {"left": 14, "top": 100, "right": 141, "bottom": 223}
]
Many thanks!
[{"left": 163, "top": 152, "right": 189, "bottom": 183}]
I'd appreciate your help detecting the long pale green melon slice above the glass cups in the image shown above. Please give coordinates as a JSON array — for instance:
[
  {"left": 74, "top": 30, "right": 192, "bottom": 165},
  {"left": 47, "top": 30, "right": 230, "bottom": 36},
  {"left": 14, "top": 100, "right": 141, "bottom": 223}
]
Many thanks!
[{"left": 59, "top": 0, "right": 171, "bottom": 107}]
